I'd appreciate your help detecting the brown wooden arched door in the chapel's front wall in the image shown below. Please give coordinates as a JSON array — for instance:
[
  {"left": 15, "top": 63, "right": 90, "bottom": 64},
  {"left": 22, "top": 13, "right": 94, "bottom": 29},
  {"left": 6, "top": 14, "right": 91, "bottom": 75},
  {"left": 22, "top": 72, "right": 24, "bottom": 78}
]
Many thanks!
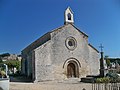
[{"left": 67, "top": 62, "right": 79, "bottom": 78}]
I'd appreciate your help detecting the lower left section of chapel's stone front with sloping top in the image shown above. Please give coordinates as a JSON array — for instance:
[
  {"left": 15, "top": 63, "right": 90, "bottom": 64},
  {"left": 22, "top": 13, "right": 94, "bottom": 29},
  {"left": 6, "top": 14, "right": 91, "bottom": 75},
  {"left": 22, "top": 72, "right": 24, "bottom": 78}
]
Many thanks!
[{"left": 34, "top": 41, "right": 53, "bottom": 81}]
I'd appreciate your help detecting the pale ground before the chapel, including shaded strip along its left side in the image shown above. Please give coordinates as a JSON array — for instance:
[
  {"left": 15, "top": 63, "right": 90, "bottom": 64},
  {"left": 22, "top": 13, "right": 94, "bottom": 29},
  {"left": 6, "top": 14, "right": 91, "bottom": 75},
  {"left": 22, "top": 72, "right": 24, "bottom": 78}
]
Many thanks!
[{"left": 9, "top": 76, "right": 92, "bottom": 90}]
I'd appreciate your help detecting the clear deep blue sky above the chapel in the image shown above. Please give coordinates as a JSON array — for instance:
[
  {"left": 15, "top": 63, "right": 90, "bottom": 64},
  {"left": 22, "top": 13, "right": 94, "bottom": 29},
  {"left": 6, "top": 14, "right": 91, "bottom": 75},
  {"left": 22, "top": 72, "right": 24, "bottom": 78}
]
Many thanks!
[{"left": 0, "top": 0, "right": 120, "bottom": 57}]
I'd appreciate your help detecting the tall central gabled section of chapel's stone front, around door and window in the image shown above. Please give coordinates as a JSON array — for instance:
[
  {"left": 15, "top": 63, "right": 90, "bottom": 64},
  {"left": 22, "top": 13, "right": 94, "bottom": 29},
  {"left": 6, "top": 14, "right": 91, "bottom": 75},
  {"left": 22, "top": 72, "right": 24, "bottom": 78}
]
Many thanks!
[{"left": 51, "top": 25, "right": 90, "bottom": 79}]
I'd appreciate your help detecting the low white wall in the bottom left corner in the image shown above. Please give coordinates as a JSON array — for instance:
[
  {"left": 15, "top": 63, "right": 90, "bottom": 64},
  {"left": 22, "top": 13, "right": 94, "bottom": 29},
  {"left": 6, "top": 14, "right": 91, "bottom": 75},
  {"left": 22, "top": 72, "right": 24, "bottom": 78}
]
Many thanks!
[{"left": 0, "top": 78, "right": 9, "bottom": 90}]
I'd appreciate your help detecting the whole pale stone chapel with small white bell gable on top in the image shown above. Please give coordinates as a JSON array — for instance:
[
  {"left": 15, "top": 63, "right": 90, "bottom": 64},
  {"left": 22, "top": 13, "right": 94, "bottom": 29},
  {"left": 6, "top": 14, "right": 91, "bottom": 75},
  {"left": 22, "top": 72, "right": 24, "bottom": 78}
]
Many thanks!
[{"left": 21, "top": 7, "right": 100, "bottom": 82}]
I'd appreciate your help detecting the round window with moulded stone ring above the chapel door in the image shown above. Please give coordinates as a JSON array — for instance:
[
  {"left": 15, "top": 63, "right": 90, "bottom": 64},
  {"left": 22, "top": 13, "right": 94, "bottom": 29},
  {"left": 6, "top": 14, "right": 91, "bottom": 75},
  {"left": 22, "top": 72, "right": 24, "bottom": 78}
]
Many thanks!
[{"left": 66, "top": 37, "right": 77, "bottom": 50}]
